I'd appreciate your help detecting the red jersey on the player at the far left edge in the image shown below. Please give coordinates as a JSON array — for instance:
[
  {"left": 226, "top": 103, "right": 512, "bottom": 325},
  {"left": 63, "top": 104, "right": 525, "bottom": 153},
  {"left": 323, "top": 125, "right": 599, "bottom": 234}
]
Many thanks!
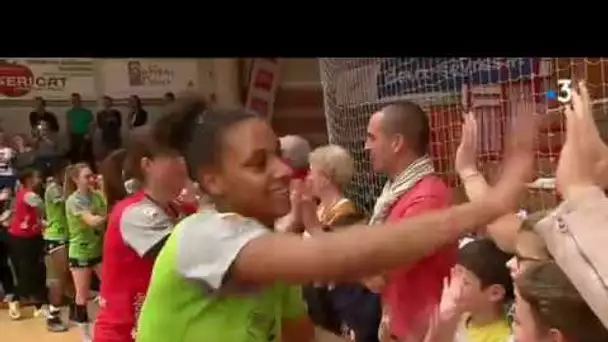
[{"left": 8, "top": 187, "right": 42, "bottom": 238}]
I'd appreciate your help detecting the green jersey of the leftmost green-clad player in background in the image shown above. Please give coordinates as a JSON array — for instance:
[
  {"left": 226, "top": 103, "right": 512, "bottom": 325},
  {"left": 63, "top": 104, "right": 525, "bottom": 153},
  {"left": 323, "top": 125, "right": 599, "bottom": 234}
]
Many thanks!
[{"left": 44, "top": 182, "right": 68, "bottom": 241}]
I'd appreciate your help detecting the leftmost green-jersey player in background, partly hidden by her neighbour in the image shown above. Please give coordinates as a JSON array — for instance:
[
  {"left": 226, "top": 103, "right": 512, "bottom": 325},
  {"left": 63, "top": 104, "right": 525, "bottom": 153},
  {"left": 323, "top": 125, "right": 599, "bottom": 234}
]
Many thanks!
[{"left": 43, "top": 165, "right": 70, "bottom": 330}]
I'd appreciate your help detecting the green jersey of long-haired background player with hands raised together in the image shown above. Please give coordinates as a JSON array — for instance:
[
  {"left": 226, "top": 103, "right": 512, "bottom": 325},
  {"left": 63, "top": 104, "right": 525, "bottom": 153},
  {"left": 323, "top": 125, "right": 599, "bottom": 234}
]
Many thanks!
[{"left": 65, "top": 191, "right": 107, "bottom": 260}]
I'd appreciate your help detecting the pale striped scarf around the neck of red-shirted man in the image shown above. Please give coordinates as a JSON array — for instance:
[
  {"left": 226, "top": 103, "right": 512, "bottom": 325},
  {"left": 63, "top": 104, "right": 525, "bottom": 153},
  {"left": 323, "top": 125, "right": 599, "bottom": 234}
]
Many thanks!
[{"left": 369, "top": 155, "right": 435, "bottom": 225}]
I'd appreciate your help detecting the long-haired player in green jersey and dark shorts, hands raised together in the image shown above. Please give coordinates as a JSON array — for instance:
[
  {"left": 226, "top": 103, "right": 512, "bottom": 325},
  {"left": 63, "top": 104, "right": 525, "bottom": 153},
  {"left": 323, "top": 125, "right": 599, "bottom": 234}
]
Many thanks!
[{"left": 64, "top": 163, "right": 107, "bottom": 340}]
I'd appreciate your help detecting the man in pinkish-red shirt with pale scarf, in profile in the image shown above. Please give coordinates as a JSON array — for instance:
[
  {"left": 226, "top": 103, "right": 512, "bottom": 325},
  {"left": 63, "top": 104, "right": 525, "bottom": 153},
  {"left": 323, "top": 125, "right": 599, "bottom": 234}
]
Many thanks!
[{"left": 365, "top": 101, "right": 457, "bottom": 341}]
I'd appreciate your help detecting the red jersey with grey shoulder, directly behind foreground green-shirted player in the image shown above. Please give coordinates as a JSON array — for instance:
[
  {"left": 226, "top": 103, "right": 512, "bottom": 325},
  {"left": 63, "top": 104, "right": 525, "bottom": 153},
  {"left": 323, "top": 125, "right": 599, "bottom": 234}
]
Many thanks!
[{"left": 94, "top": 191, "right": 189, "bottom": 342}]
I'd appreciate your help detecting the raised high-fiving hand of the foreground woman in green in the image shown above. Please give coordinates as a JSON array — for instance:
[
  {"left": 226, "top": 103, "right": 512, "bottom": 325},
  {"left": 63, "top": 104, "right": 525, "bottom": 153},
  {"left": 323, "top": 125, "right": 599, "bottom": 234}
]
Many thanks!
[{"left": 481, "top": 109, "right": 537, "bottom": 216}]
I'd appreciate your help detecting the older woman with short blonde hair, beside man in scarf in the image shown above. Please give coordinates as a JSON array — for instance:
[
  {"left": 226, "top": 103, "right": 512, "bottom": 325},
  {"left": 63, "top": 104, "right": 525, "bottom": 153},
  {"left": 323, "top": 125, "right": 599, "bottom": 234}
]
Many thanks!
[{"left": 304, "top": 145, "right": 380, "bottom": 342}]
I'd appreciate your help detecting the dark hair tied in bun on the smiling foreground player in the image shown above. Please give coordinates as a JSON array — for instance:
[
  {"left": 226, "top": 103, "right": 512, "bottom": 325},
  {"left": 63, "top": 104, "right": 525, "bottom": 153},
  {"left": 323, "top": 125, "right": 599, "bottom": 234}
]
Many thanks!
[{"left": 154, "top": 95, "right": 259, "bottom": 180}]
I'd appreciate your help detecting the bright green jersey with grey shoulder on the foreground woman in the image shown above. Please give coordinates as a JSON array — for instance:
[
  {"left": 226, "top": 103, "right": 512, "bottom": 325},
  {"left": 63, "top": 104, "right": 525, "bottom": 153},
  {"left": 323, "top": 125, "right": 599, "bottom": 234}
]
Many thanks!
[{"left": 136, "top": 211, "right": 306, "bottom": 342}]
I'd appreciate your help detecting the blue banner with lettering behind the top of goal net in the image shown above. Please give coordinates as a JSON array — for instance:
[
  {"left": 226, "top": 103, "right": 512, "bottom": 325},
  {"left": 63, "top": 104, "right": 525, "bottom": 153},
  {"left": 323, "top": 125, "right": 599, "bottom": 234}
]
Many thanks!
[{"left": 376, "top": 57, "right": 535, "bottom": 99}]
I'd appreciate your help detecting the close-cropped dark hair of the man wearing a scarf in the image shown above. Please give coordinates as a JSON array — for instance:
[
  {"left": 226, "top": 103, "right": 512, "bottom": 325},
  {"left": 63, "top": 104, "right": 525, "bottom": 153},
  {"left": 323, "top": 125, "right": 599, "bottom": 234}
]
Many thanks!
[{"left": 380, "top": 101, "right": 430, "bottom": 156}]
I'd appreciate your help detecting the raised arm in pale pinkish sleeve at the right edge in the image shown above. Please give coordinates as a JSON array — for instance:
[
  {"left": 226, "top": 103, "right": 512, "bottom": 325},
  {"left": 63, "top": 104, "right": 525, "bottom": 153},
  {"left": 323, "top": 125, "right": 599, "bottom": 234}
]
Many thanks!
[{"left": 536, "top": 81, "right": 608, "bottom": 330}]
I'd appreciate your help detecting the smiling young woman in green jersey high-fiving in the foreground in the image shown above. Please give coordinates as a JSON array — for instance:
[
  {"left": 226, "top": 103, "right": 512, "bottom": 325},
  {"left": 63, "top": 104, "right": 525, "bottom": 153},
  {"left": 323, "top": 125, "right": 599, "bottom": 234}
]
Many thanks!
[{"left": 137, "top": 98, "right": 535, "bottom": 342}]
